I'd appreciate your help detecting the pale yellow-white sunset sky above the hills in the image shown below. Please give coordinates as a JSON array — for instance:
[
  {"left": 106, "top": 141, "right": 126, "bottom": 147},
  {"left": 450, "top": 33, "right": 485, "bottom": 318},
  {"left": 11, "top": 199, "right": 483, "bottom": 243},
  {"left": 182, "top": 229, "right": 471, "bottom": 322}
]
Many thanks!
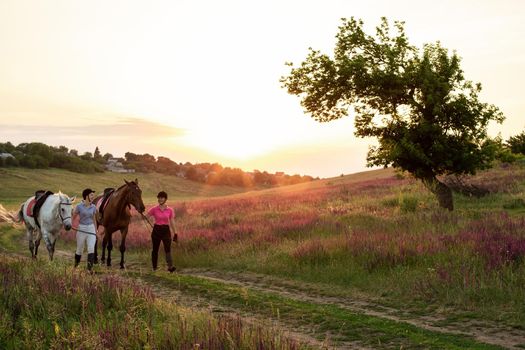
[{"left": 0, "top": 0, "right": 525, "bottom": 177}]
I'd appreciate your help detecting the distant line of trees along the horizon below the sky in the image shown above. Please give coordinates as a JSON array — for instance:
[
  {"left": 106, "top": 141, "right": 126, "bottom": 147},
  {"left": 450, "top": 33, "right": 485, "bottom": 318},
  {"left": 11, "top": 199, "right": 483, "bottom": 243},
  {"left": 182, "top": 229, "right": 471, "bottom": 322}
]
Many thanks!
[{"left": 0, "top": 142, "right": 314, "bottom": 187}]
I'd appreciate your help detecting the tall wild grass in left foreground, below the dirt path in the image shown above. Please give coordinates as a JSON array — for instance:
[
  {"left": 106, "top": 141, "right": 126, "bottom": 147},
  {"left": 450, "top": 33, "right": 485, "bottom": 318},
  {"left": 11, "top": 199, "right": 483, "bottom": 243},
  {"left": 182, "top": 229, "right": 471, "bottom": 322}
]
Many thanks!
[{"left": 0, "top": 257, "right": 304, "bottom": 349}]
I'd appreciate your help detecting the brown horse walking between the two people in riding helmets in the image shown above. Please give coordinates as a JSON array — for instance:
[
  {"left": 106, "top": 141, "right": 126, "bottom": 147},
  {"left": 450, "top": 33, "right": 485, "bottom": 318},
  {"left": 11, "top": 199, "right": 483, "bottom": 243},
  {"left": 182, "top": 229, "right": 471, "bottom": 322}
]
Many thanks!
[{"left": 94, "top": 179, "right": 146, "bottom": 269}]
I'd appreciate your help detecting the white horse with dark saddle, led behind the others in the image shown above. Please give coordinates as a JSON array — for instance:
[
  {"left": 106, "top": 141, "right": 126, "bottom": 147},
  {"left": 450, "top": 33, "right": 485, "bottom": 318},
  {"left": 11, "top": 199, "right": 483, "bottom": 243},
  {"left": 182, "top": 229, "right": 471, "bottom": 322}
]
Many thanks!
[{"left": 18, "top": 192, "right": 76, "bottom": 260}]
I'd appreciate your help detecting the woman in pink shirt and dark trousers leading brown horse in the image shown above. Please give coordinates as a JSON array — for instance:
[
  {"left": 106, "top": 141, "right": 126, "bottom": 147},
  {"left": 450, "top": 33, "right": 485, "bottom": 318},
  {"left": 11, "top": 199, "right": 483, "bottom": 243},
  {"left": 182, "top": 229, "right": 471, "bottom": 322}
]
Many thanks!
[{"left": 147, "top": 191, "right": 177, "bottom": 272}]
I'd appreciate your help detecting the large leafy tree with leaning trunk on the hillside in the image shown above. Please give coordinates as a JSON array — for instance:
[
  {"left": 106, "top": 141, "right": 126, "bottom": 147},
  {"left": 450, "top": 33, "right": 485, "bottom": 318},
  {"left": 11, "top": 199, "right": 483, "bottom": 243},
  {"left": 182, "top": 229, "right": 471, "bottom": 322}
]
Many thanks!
[{"left": 281, "top": 18, "right": 504, "bottom": 210}]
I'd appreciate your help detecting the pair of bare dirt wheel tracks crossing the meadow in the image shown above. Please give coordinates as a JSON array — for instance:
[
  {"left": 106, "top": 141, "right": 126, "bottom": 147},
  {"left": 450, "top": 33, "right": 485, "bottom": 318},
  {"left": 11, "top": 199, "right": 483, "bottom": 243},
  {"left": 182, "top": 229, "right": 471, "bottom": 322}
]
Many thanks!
[{"left": 6, "top": 241, "right": 525, "bottom": 349}]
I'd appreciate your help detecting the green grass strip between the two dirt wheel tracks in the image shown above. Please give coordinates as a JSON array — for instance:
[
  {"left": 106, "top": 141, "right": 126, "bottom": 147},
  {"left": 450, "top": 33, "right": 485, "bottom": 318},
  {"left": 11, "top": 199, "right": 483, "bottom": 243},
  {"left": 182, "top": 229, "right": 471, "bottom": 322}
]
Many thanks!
[{"left": 134, "top": 274, "right": 499, "bottom": 349}]
